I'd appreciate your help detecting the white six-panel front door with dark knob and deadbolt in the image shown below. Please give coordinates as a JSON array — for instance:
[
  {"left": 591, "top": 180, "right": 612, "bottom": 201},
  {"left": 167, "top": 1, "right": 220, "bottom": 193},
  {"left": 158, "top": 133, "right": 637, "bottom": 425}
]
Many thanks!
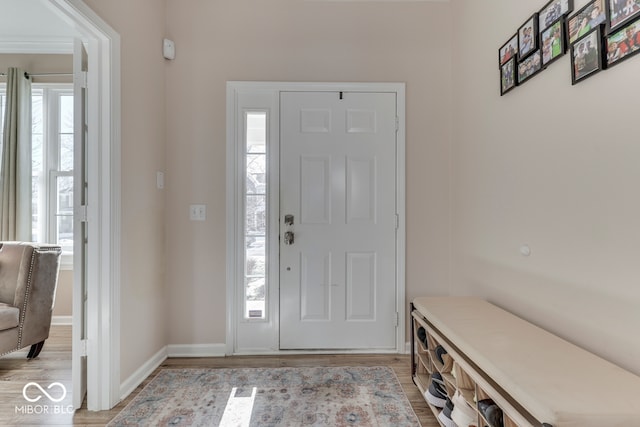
[{"left": 279, "top": 92, "right": 398, "bottom": 349}]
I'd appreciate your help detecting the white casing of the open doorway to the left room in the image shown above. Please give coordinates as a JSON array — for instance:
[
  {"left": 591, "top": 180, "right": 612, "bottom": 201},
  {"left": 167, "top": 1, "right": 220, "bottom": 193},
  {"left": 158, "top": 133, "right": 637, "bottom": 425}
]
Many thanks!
[{"left": 45, "top": 0, "right": 121, "bottom": 411}]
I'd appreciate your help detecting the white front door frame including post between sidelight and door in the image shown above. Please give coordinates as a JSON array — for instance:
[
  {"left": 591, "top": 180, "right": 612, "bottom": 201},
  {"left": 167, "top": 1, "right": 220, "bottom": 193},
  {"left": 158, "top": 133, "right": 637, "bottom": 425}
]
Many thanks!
[{"left": 226, "top": 81, "right": 406, "bottom": 355}]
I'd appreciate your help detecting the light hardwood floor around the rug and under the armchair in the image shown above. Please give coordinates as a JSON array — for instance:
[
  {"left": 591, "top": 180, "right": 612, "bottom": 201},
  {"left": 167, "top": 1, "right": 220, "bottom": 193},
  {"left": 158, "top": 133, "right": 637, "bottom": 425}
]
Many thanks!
[{"left": 0, "top": 326, "right": 440, "bottom": 427}]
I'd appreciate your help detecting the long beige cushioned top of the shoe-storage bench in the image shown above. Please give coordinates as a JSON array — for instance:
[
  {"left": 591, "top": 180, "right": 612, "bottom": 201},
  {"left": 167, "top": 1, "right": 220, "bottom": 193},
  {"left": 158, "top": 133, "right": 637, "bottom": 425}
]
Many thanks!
[{"left": 413, "top": 297, "right": 640, "bottom": 427}]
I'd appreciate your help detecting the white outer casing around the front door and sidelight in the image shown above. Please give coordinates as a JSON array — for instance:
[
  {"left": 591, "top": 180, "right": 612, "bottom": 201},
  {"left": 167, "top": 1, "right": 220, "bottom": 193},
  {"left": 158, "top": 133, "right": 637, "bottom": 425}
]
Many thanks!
[{"left": 226, "top": 81, "right": 406, "bottom": 355}]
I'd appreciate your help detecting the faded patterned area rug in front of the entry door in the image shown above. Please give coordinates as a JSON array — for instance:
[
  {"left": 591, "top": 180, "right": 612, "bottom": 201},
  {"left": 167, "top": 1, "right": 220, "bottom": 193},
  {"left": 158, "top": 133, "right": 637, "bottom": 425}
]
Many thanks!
[{"left": 108, "top": 367, "right": 420, "bottom": 427}]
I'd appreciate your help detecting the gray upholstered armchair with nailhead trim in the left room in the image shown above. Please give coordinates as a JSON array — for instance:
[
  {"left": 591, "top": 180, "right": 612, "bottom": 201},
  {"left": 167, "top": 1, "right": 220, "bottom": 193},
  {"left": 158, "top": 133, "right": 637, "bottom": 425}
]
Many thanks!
[{"left": 0, "top": 242, "right": 62, "bottom": 359}]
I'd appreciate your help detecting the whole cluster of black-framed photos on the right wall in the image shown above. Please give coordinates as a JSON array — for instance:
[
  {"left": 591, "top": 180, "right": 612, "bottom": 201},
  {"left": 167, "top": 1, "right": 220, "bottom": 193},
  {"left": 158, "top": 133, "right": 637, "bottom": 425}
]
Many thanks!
[{"left": 498, "top": 0, "right": 640, "bottom": 95}]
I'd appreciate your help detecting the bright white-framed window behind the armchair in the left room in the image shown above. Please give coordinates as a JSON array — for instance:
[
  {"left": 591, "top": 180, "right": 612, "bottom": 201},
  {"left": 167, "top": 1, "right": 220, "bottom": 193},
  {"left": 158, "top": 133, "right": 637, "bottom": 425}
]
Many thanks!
[{"left": 0, "top": 84, "right": 73, "bottom": 267}]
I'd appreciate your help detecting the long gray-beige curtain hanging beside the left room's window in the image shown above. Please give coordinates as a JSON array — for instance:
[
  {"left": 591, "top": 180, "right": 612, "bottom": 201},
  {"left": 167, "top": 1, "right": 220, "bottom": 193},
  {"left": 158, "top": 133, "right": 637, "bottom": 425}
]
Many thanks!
[{"left": 0, "top": 68, "right": 31, "bottom": 241}]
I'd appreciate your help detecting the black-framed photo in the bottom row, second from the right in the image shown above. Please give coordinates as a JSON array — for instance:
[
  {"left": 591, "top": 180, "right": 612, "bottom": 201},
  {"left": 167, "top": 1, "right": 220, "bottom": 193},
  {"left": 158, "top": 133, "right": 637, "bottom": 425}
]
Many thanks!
[{"left": 571, "top": 25, "right": 604, "bottom": 85}]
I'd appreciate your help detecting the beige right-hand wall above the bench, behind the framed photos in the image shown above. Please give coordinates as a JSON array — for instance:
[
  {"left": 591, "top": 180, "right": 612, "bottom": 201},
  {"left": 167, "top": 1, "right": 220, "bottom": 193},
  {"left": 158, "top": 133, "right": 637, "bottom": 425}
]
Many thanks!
[{"left": 452, "top": 0, "right": 640, "bottom": 374}]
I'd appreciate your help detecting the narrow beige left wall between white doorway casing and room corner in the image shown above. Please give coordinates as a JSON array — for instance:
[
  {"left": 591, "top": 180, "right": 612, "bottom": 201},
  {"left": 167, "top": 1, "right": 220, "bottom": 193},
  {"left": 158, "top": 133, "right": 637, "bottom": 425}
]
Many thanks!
[{"left": 86, "top": 0, "right": 168, "bottom": 381}]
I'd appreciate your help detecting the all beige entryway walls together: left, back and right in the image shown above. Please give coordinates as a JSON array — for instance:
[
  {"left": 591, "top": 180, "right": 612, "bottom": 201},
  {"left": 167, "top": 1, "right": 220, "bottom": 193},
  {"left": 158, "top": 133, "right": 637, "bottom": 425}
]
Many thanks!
[{"left": 70, "top": 0, "right": 640, "bottom": 384}]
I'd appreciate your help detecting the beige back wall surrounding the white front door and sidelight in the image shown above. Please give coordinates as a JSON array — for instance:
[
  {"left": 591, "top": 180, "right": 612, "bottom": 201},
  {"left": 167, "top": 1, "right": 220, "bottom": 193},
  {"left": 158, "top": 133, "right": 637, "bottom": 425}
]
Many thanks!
[{"left": 167, "top": 0, "right": 451, "bottom": 344}]
